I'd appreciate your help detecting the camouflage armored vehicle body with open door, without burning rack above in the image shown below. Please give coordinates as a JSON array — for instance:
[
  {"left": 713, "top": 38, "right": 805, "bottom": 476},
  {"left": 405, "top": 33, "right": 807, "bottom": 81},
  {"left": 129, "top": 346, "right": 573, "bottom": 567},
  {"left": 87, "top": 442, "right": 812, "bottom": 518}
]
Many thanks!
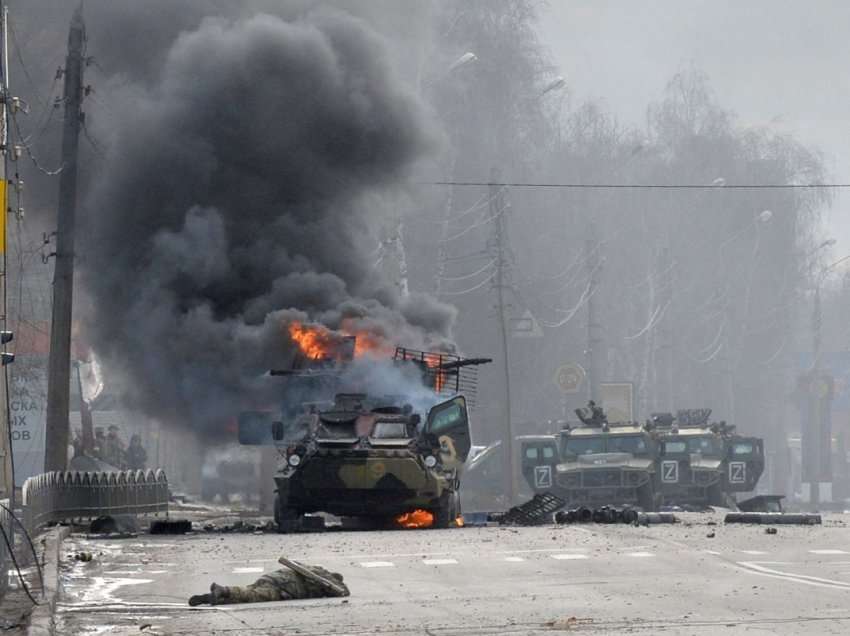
[{"left": 273, "top": 394, "right": 471, "bottom": 528}]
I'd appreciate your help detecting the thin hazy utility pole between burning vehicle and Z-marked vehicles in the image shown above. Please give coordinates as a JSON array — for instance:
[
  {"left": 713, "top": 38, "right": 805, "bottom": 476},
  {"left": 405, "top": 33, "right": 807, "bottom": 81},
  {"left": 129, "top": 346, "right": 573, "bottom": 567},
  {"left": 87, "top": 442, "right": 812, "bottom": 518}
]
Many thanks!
[{"left": 488, "top": 168, "right": 517, "bottom": 506}]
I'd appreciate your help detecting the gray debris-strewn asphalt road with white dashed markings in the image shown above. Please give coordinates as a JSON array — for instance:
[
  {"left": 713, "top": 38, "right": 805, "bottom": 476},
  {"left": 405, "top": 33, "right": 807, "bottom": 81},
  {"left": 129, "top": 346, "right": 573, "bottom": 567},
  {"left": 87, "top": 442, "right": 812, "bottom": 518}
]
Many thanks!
[{"left": 57, "top": 515, "right": 850, "bottom": 636}]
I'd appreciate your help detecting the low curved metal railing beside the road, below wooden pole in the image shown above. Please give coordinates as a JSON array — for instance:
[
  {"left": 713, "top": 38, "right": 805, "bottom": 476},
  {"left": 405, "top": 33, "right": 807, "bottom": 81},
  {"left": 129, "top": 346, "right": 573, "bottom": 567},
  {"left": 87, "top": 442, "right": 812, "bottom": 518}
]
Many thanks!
[{"left": 23, "top": 470, "right": 169, "bottom": 533}]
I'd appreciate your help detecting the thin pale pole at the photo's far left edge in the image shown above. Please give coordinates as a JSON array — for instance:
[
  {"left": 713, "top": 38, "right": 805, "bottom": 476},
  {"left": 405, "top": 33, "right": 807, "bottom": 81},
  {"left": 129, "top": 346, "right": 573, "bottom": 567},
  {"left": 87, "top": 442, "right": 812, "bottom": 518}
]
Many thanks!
[{"left": 0, "top": 4, "right": 15, "bottom": 507}]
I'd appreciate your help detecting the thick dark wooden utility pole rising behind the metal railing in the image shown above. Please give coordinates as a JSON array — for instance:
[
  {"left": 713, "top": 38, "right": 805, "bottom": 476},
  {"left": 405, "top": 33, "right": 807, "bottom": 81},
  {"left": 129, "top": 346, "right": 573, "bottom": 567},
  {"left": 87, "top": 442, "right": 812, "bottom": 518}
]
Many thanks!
[{"left": 44, "top": 4, "right": 86, "bottom": 471}]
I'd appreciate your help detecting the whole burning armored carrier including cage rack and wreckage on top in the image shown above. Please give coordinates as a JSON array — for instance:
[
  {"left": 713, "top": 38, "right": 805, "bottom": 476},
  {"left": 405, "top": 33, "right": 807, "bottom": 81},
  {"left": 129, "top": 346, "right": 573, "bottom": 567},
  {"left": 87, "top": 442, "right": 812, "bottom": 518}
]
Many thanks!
[{"left": 240, "top": 322, "right": 489, "bottom": 530}]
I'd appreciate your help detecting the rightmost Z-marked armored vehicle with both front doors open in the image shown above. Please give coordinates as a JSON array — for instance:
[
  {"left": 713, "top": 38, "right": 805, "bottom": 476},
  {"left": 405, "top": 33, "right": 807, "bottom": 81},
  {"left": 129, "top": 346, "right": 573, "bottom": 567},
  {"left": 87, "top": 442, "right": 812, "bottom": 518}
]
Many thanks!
[{"left": 652, "top": 409, "right": 764, "bottom": 507}]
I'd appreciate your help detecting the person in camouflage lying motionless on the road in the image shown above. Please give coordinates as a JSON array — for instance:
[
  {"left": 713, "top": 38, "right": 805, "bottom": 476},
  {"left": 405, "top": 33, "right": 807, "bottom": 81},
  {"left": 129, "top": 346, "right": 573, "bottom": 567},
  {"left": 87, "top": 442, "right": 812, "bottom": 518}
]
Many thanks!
[{"left": 189, "top": 565, "right": 349, "bottom": 607}]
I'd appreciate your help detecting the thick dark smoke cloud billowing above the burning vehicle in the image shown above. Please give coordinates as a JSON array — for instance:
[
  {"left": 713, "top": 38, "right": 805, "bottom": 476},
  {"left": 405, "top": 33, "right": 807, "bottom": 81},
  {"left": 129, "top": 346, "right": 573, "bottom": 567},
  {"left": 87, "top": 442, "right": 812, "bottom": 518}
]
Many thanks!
[{"left": 81, "top": 12, "right": 454, "bottom": 438}]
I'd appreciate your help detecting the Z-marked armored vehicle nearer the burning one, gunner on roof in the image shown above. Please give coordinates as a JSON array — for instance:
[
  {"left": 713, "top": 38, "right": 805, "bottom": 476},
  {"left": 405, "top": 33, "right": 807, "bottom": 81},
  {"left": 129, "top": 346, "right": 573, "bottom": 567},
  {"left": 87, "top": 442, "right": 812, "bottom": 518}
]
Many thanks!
[{"left": 521, "top": 402, "right": 659, "bottom": 510}]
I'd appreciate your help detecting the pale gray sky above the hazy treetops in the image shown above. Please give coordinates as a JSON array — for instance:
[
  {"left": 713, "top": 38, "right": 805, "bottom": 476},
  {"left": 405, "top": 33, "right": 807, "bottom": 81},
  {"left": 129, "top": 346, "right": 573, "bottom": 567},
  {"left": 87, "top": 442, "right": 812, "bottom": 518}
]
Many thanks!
[{"left": 540, "top": 0, "right": 850, "bottom": 259}]
